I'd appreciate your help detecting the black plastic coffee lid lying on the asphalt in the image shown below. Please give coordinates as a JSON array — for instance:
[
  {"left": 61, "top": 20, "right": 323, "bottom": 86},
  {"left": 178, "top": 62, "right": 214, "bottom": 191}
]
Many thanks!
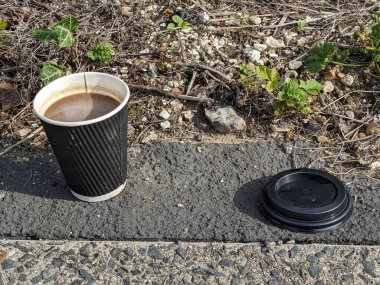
[{"left": 261, "top": 169, "right": 353, "bottom": 233}]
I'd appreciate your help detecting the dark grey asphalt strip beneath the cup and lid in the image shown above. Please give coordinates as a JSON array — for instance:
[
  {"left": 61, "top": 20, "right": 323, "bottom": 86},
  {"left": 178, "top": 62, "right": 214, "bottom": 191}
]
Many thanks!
[{"left": 0, "top": 142, "right": 380, "bottom": 244}]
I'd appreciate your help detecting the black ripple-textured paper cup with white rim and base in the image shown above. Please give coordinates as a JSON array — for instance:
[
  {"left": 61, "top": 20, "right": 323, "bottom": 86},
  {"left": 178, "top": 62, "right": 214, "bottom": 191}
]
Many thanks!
[{"left": 33, "top": 72, "right": 130, "bottom": 202}]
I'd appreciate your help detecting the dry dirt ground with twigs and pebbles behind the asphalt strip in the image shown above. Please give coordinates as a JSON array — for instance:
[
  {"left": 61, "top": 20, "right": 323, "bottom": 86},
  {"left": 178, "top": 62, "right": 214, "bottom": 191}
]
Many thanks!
[{"left": 0, "top": 0, "right": 380, "bottom": 176}]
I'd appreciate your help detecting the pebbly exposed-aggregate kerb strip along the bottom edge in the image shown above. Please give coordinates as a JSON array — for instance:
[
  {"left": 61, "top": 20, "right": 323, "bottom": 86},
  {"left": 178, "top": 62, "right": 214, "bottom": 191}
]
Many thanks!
[{"left": 0, "top": 240, "right": 380, "bottom": 285}]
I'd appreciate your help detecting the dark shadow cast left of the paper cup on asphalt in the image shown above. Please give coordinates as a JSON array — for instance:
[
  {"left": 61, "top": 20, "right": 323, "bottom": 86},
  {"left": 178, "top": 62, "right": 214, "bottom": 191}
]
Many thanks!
[{"left": 0, "top": 156, "right": 78, "bottom": 201}]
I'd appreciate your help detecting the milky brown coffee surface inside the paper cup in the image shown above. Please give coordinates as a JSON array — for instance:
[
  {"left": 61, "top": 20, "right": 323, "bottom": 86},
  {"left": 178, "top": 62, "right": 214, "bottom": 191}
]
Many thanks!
[{"left": 44, "top": 92, "right": 120, "bottom": 122}]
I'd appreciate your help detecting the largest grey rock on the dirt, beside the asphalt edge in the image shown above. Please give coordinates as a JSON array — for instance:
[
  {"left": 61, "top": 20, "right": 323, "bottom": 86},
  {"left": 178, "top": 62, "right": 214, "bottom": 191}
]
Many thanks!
[{"left": 205, "top": 107, "right": 246, "bottom": 134}]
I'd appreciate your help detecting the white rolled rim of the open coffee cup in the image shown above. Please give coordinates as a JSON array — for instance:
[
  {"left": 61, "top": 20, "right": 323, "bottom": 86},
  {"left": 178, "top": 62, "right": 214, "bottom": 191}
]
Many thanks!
[{"left": 33, "top": 71, "right": 130, "bottom": 127}]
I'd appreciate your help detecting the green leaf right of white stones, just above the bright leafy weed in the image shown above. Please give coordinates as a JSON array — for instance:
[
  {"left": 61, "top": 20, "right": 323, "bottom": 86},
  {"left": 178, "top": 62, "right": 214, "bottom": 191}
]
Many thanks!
[{"left": 306, "top": 41, "right": 337, "bottom": 73}]
